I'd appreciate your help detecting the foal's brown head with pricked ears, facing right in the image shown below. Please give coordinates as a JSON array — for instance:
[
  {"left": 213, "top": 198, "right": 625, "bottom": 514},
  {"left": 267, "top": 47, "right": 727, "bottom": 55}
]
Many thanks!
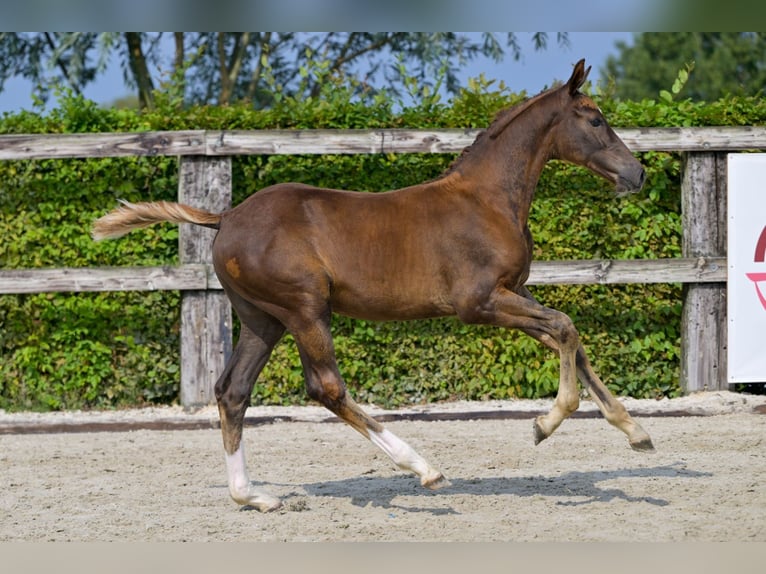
[{"left": 552, "top": 60, "right": 645, "bottom": 195}]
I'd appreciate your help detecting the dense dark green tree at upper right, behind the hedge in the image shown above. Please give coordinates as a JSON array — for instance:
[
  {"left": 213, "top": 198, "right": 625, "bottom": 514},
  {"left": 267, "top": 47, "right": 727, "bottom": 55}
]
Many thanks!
[{"left": 601, "top": 32, "right": 766, "bottom": 101}]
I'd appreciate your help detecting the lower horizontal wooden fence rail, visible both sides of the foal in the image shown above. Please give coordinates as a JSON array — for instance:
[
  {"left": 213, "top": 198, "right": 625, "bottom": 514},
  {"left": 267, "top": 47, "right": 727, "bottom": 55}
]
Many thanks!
[{"left": 0, "top": 257, "right": 727, "bottom": 294}]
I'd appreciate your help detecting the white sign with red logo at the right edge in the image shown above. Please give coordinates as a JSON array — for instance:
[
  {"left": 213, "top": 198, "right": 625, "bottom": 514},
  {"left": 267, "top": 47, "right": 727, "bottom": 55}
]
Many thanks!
[{"left": 727, "top": 153, "right": 766, "bottom": 383}]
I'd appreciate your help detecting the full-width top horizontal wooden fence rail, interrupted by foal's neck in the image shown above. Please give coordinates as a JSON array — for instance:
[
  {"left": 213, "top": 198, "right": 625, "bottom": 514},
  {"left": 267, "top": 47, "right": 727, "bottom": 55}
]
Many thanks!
[{"left": 0, "top": 126, "right": 766, "bottom": 160}]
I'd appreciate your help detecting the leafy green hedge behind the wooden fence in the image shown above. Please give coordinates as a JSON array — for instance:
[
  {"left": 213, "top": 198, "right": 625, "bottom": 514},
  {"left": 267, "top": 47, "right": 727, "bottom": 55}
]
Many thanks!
[{"left": 0, "top": 82, "right": 766, "bottom": 410}]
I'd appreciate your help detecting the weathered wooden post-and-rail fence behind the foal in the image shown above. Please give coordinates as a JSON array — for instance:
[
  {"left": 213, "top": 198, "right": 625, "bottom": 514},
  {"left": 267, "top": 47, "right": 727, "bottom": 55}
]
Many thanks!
[{"left": 0, "top": 127, "right": 766, "bottom": 407}]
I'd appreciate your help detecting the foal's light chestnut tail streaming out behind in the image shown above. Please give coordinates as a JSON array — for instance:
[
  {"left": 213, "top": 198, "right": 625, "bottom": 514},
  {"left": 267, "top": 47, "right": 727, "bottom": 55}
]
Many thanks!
[{"left": 92, "top": 201, "right": 221, "bottom": 241}]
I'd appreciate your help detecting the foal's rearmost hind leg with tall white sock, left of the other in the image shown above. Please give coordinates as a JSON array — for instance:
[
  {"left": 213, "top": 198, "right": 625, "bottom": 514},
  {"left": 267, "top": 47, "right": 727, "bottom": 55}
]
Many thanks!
[{"left": 215, "top": 309, "right": 285, "bottom": 512}]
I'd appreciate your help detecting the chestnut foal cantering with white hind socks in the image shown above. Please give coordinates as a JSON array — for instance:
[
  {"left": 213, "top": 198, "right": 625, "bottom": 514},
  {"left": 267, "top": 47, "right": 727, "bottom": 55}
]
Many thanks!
[{"left": 94, "top": 60, "right": 653, "bottom": 511}]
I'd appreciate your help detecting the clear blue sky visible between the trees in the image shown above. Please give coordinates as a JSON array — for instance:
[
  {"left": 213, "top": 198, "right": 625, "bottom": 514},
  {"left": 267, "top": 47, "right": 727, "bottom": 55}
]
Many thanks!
[{"left": 0, "top": 32, "right": 634, "bottom": 113}]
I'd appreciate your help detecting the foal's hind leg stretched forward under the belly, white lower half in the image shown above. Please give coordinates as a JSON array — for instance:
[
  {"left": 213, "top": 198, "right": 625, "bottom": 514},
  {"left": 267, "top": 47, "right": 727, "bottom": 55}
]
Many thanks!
[{"left": 291, "top": 312, "right": 450, "bottom": 490}]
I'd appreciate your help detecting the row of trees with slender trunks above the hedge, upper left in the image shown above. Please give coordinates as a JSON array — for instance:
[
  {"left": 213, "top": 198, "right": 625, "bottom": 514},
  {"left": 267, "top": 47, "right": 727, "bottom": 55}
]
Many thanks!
[{"left": 0, "top": 32, "right": 568, "bottom": 108}]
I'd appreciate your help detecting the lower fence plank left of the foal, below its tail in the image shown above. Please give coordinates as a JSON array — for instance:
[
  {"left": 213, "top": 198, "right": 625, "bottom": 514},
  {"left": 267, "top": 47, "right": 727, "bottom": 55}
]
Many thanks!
[{"left": 0, "top": 265, "right": 210, "bottom": 295}]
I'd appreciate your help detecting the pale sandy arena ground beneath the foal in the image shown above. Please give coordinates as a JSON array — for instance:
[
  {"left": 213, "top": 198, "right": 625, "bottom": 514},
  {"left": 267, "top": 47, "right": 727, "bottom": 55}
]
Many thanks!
[{"left": 0, "top": 392, "right": 766, "bottom": 542}]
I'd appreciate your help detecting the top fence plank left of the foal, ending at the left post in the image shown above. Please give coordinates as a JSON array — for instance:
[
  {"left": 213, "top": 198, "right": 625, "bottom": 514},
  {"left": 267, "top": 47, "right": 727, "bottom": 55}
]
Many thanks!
[{"left": 0, "top": 130, "right": 206, "bottom": 159}]
